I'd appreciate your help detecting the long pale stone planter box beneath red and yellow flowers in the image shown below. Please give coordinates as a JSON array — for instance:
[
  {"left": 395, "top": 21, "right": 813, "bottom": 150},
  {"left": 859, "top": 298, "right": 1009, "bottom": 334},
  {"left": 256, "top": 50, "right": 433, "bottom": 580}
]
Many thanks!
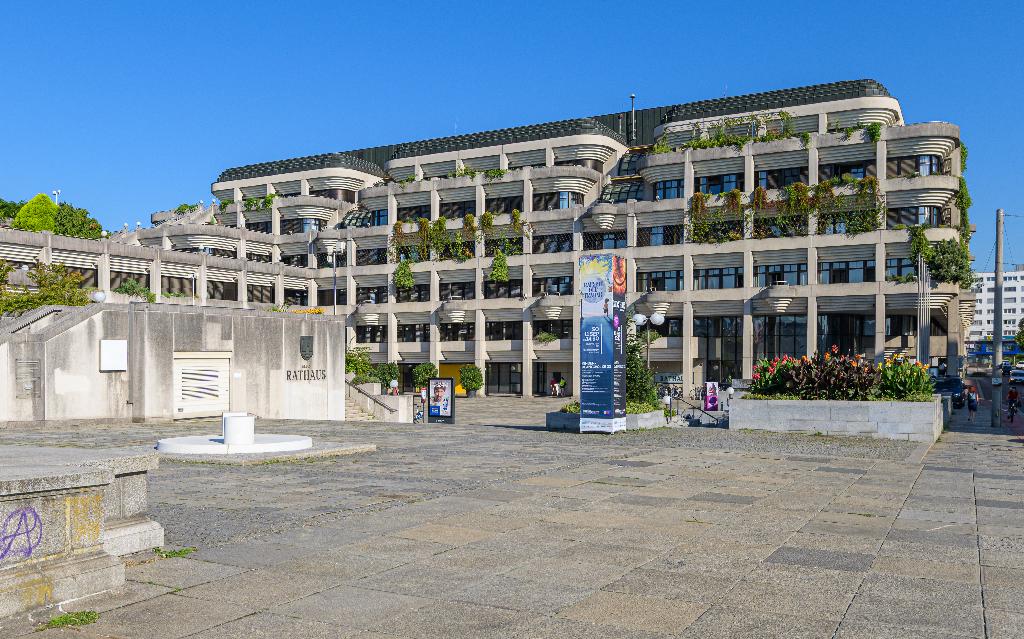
[{"left": 729, "top": 395, "right": 943, "bottom": 442}]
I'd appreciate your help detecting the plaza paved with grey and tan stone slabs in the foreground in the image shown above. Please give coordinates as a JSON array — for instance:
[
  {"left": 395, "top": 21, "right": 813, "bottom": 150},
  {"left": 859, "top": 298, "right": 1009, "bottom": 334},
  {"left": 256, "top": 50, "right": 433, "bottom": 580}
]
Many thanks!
[{"left": 0, "top": 398, "right": 1024, "bottom": 639}]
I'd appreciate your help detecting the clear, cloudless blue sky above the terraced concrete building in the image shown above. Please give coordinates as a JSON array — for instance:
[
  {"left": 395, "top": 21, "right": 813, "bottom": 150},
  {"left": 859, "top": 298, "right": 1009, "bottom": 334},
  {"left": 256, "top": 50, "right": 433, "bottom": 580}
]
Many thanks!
[{"left": 0, "top": 1, "right": 1024, "bottom": 269}]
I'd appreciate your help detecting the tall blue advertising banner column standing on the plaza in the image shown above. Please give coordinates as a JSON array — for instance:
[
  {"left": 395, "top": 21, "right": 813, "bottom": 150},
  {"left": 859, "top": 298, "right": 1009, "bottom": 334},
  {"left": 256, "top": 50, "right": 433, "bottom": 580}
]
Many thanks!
[{"left": 580, "top": 255, "right": 626, "bottom": 432}]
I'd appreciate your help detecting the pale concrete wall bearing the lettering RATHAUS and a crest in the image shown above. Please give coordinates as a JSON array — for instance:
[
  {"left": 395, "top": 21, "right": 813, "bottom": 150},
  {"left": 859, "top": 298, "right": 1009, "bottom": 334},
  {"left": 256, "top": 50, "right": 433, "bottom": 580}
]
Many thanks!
[{"left": 0, "top": 304, "right": 345, "bottom": 421}]
